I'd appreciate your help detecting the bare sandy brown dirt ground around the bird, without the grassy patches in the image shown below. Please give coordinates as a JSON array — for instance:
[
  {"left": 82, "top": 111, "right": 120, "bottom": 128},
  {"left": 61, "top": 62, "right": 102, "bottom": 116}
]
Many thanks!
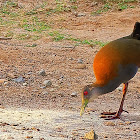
[{"left": 0, "top": 1, "right": 140, "bottom": 140}]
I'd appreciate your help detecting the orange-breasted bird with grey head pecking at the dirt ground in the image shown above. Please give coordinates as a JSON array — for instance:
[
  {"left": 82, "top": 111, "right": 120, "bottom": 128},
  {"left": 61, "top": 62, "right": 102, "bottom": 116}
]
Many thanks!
[{"left": 80, "top": 22, "right": 140, "bottom": 120}]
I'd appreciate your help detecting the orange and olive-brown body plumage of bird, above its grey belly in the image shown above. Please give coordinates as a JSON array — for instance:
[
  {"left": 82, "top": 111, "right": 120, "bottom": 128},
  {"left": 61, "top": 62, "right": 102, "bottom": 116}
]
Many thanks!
[{"left": 93, "top": 39, "right": 140, "bottom": 85}]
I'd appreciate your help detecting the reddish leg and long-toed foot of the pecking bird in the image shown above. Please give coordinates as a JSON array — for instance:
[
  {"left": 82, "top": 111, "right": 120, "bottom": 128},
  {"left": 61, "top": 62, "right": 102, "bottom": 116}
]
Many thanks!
[{"left": 101, "top": 82, "right": 128, "bottom": 120}]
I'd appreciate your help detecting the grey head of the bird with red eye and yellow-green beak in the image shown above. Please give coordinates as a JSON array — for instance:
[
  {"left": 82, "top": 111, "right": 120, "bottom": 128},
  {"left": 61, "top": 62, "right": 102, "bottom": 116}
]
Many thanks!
[{"left": 80, "top": 85, "right": 98, "bottom": 116}]
